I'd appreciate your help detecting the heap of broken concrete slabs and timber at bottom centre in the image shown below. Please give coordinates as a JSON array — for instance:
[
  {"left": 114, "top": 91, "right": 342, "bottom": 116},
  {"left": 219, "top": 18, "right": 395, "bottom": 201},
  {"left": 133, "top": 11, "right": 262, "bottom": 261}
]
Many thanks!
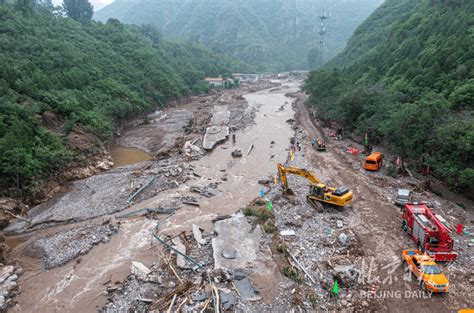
[{"left": 101, "top": 207, "right": 278, "bottom": 312}]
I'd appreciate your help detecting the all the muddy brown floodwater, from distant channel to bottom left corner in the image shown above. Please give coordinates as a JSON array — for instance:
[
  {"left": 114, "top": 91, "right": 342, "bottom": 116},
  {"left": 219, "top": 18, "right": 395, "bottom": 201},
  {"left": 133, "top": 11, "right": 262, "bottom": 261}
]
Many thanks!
[{"left": 12, "top": 84, "right": 298, "bottom": 312}]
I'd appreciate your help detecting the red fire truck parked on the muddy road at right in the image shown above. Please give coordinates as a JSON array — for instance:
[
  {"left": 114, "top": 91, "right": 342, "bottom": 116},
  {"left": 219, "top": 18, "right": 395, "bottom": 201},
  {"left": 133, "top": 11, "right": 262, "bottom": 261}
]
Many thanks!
[{"left": 401, "top": 202, "right": 458, "bottom": 262}]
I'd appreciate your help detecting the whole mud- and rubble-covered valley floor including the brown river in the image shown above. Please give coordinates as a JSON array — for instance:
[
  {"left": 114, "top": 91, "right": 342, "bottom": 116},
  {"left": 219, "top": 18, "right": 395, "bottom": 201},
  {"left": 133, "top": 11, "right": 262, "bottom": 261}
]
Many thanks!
[{"left": 1, "top": 82, "right": 474, "bottom": 312}]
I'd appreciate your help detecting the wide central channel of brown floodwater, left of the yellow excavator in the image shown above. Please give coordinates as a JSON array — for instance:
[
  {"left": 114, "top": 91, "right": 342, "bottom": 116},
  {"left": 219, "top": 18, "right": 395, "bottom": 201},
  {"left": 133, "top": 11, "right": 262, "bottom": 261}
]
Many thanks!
[{"left": 164, "top": 85, "right": 298, "bottom": 233}]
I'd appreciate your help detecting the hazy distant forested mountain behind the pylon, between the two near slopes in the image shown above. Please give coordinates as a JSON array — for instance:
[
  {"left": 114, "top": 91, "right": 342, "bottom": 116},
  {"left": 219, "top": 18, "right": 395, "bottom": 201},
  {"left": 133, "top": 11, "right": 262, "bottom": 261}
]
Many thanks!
[{"left": 94, "top": 0, "right": 382, "bottom": 71}]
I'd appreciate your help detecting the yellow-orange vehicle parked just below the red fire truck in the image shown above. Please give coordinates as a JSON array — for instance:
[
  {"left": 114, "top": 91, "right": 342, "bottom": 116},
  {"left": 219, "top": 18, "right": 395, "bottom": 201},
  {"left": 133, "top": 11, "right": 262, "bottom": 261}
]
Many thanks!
[{"left": 402, "top": 250, "right": 449, "bottom": 292}]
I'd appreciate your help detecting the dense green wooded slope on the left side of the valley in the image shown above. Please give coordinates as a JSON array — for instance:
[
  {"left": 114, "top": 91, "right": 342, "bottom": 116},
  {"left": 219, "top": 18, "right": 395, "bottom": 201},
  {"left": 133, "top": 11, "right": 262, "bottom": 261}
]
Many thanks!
[{"left": 0, "top": 1, "right": 245, "bottom": 195}]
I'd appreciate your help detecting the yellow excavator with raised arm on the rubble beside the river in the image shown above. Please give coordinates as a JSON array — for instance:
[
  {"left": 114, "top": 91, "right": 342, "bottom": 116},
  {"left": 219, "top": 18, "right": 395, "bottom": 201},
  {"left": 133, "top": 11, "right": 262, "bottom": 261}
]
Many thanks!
[{"left": 277, "top": 163, "right": 352, "bottom": 212}]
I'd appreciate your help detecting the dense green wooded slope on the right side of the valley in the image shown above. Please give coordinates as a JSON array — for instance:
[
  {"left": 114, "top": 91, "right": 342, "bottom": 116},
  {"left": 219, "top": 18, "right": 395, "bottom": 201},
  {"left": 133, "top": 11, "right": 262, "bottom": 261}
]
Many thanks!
[{"left": 306, "top": 0, "right": 474, "bottom": 192}]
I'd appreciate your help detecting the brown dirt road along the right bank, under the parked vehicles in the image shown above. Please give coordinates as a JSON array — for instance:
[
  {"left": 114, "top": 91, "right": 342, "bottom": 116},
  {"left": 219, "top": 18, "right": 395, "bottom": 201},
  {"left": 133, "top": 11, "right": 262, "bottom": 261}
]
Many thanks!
[{"left": 290, "top": 94, "right": 474, "bottom": 312}]
